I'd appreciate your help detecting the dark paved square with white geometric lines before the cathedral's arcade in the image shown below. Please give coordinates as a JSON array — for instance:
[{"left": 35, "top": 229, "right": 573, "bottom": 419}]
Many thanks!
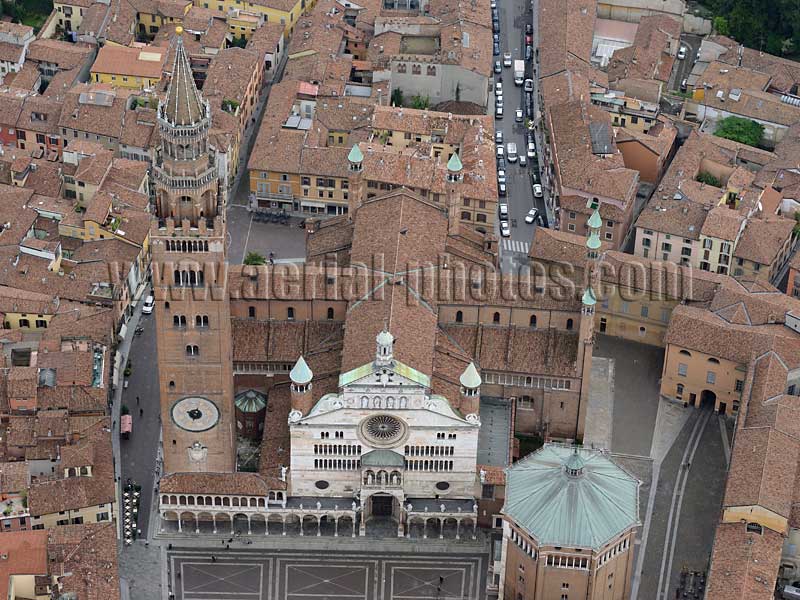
[{"left": 169, "top": 549, "right": 488, "bottom": 600}]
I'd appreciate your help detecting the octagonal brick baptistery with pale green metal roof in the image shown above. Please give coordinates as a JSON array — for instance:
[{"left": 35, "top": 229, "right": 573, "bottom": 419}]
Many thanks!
[{"left": 500, "top": 444, "right": 641, "bottom": 600}]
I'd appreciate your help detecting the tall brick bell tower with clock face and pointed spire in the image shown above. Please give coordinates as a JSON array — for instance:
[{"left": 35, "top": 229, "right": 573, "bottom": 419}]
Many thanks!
[{"left": 150, "top": 27, "right": 236, "bottom": 473}]
